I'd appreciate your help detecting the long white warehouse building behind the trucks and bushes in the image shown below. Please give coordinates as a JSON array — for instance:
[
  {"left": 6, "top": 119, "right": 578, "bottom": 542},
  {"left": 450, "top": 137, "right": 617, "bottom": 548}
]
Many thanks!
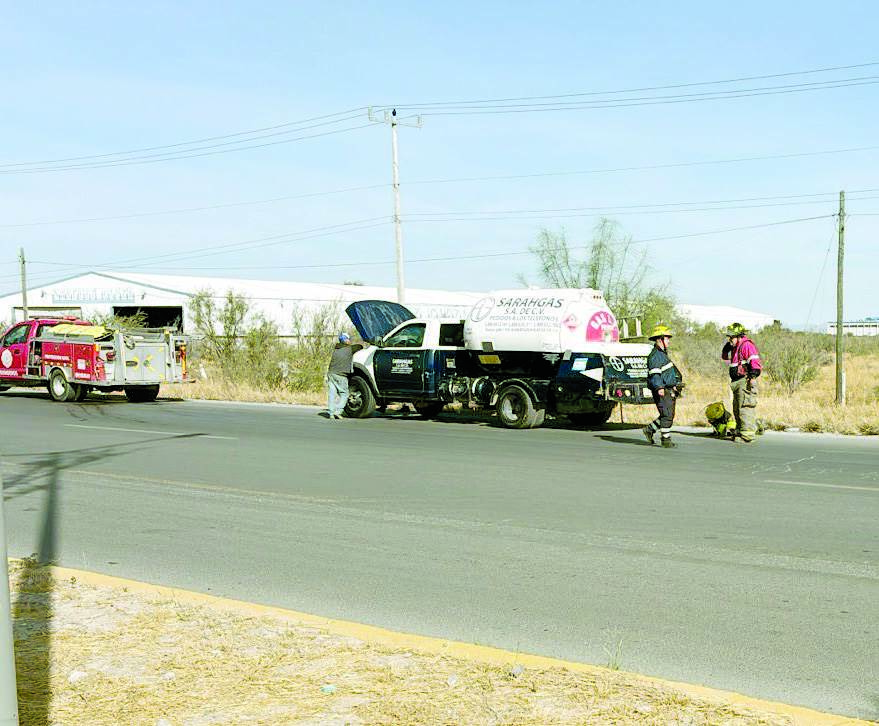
[{"left": 0, "top": 272, "right": 774, "bottom": 336}]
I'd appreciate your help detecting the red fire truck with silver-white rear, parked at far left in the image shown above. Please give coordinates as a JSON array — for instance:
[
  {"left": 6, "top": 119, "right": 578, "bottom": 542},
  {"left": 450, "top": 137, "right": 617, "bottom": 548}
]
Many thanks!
[{"left": 0, "top": 317, "right": 188, "bottom": 402}]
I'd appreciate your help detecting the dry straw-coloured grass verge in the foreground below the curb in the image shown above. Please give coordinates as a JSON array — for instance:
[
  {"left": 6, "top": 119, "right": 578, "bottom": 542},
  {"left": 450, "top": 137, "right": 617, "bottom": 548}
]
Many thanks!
[{"left": 10, "top": 561, "right": 790, "bottom": 726}]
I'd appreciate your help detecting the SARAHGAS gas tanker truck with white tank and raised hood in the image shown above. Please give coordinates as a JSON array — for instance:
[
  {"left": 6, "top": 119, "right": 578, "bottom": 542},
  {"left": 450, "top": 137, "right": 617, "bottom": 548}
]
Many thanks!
[{"left": 345, "top": 289, "right": 653, "bottom": 428}]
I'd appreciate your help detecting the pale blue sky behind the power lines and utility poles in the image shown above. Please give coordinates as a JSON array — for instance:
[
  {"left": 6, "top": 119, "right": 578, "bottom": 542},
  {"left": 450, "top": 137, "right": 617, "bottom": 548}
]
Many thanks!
[{"left": 0, "top": 2, "right": 879, "bottom": 326}]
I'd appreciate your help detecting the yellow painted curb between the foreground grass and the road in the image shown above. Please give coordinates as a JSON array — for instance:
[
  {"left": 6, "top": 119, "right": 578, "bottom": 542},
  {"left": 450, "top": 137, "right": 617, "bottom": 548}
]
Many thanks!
[{"left": 20, "top": 567, "right": 872, "bottom": 726}]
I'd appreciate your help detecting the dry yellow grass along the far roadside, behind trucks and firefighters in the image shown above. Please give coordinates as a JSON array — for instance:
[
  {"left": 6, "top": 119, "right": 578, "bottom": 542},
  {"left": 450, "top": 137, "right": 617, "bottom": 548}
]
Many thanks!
[{"left": 162, "top": 356, "right": 879, "bottom": 436}]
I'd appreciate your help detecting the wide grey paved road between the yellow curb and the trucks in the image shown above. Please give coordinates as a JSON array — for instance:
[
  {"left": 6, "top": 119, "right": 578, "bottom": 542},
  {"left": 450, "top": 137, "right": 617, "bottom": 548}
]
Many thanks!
[{"left": 0, "top": 393, "right": 879, "bottom": 718}]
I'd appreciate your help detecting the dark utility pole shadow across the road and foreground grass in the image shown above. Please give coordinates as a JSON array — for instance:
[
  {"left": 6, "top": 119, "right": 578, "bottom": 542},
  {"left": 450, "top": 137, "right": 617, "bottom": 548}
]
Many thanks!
[{"left": 2, "top": 434, "right": 208, "bottom": 726}]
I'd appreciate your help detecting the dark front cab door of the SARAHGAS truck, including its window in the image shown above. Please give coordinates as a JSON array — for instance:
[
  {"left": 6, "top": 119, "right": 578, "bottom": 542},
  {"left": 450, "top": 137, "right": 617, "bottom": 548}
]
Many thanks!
[{"left": 373, "top": 323, "right": 433, "bottom": 397}]
